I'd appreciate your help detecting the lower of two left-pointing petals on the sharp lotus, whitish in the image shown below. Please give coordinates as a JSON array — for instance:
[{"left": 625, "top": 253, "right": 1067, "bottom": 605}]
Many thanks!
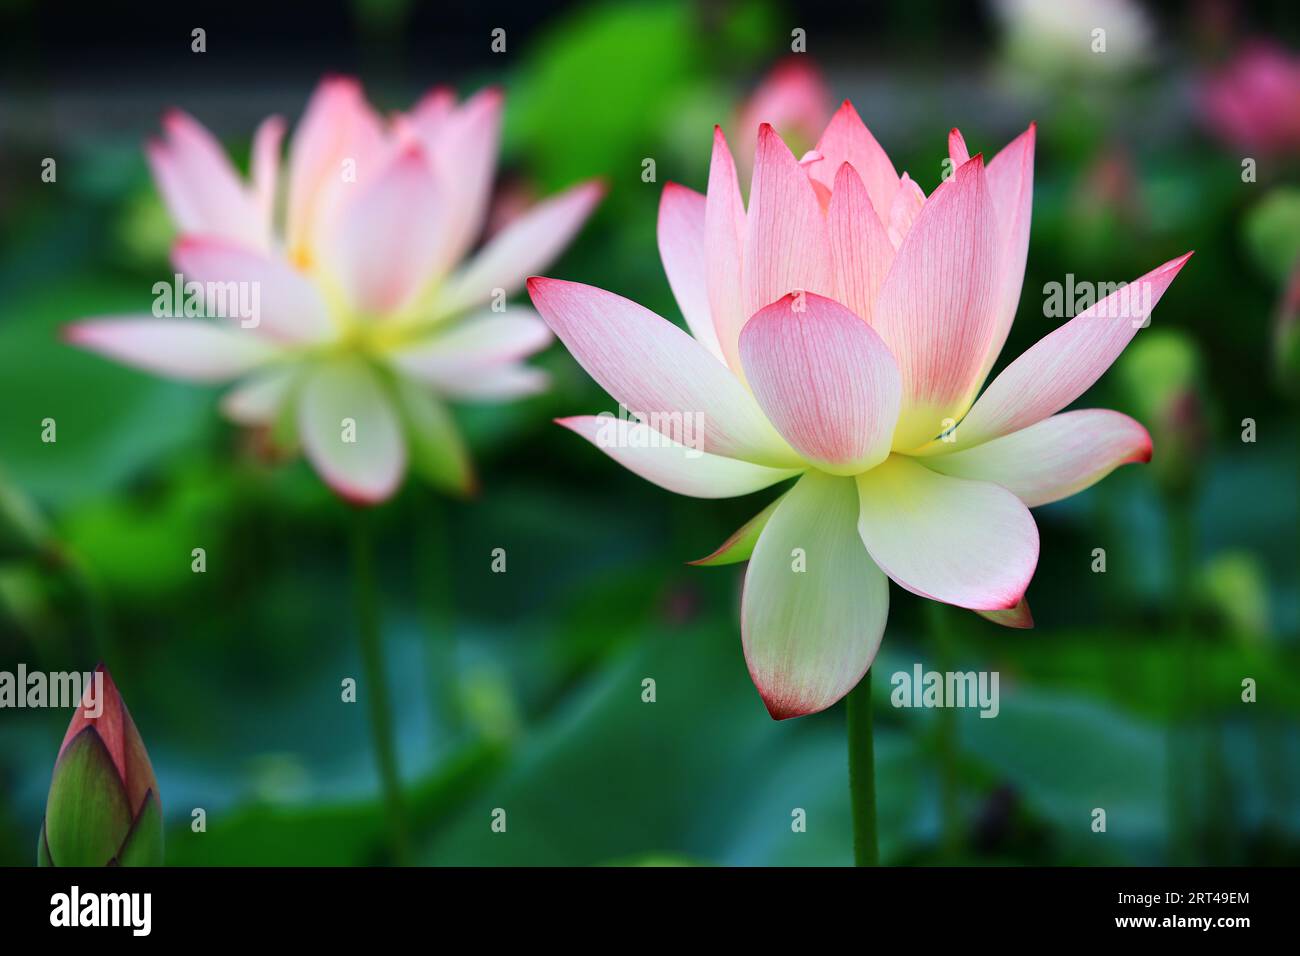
[{"left": 556, "top": 415, "right": 798, "bottom": 498}]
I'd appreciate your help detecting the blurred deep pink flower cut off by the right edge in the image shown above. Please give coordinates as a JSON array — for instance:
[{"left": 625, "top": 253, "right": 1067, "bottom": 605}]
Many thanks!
[{"left": 1200, "top": 42, "right": 1300, "bottom": 153}]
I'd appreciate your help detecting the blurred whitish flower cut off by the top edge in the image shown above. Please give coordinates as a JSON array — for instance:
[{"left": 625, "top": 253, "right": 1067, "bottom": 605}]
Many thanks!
[{"left": 992, "top": 0, "right": 1154, "bottom": 79}]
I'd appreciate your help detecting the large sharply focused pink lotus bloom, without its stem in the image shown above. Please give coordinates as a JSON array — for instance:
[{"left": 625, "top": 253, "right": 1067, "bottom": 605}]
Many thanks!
[{"left": 528, "top": 103, "right": 1187, "bottom": 719}]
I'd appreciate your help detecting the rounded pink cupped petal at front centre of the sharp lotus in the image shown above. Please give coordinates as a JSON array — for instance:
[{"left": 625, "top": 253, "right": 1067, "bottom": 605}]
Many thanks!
[{"left": 740, "top": 293, "right": 902, "bottom": 475}]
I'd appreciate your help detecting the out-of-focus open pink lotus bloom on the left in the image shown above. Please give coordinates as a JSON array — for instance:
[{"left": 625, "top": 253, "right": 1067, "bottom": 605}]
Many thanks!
[{"left": 69, "top": 78, "right": 601, "bottom": 503}]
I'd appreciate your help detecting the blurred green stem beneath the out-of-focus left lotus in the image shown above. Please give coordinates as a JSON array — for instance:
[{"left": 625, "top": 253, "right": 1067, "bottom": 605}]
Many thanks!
[{"left": 352, "top": 510, "right": 411, "bottom": 865}]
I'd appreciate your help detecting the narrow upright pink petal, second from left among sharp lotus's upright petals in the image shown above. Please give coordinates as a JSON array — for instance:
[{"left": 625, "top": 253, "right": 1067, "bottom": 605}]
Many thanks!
[{"left": 705, "top": 126, "right": 748, "bottom": 375}]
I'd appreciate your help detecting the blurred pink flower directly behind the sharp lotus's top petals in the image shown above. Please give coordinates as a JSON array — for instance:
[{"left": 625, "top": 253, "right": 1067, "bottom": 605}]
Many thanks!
[{"left": 736, "top": 53, "right": 835, "bottom": 181}]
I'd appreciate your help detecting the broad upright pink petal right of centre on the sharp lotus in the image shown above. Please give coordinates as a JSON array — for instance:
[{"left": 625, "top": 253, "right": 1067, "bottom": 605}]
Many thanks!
[{"left": 872, "top": 156, "right": 997, "bottom": 450}]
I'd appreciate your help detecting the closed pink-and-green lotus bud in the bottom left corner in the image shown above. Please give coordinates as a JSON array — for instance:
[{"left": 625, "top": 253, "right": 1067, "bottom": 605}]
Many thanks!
[{"left": 36, "top": 665, "right": 163, "bottom": 866}]
